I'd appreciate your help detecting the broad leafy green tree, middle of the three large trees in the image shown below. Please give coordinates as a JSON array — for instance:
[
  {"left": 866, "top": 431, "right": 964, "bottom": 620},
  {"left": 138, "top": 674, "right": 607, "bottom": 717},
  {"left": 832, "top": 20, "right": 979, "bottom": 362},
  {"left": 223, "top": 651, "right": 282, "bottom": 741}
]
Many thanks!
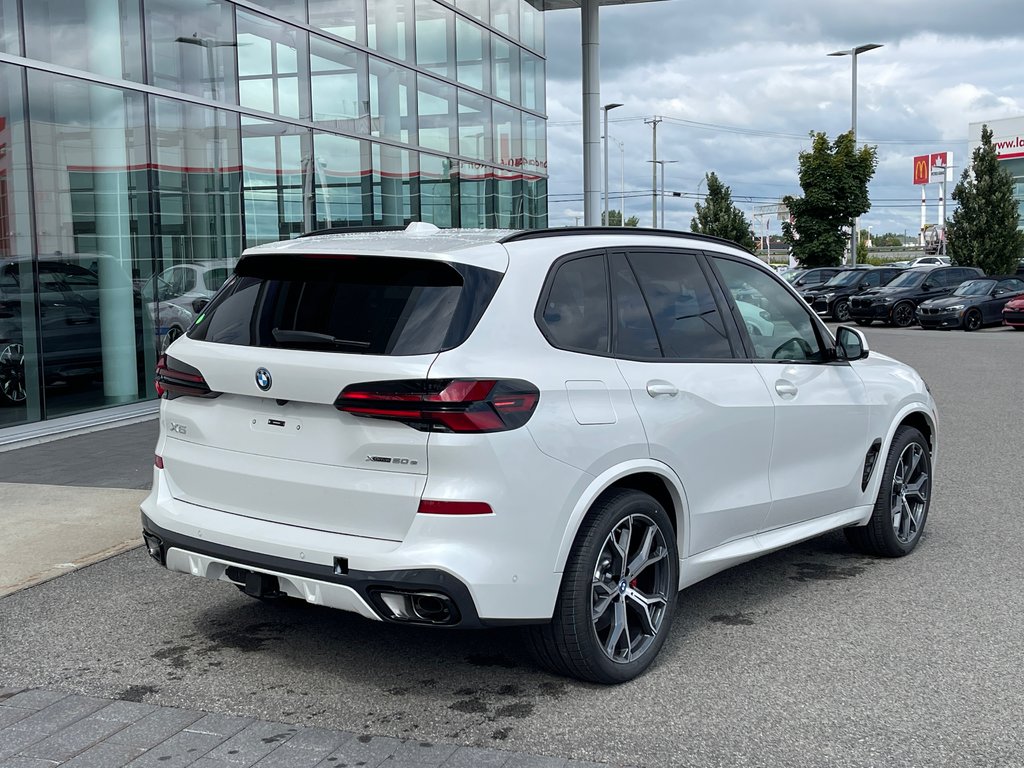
[{"left": 782, "top": 132, "right": 879, "bottom": 267}]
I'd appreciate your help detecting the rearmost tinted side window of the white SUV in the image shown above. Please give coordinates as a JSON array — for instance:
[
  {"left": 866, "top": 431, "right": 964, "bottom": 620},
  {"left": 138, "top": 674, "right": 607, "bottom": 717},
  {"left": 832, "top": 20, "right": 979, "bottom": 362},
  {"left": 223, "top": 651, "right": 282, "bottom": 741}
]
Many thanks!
[{"left": 542, "top": 256, "right": 608, "bottom": 354}]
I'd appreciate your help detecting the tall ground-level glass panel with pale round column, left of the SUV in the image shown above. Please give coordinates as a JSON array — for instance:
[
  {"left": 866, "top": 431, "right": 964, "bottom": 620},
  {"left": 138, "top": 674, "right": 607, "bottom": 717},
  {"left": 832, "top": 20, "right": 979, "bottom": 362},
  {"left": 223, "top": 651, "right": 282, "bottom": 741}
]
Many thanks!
[{"left": 29, "top": 71, "right": 156, "bottom": 416}]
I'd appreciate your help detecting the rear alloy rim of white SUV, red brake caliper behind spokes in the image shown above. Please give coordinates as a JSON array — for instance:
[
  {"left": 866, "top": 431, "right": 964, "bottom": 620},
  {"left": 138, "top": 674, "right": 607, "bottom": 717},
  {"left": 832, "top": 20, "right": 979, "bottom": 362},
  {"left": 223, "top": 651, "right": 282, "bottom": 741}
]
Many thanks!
[{"left": 591, "top": 514, "right": 675, "bottom": 664}]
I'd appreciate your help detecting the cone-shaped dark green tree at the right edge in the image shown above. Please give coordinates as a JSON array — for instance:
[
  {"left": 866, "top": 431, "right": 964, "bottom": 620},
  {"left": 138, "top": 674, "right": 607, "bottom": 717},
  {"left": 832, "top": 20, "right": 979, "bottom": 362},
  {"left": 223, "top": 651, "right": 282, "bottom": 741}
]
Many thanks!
[{"left": 946, "top": 125, "right": 1024, "bottom": 274}]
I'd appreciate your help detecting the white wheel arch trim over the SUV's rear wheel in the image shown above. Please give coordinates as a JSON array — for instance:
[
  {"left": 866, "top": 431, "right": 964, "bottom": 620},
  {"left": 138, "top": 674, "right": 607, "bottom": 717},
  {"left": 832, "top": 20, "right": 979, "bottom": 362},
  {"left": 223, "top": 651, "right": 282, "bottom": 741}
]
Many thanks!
[{"left": 555, "top": 461, "right": 689, "bottom": 573}]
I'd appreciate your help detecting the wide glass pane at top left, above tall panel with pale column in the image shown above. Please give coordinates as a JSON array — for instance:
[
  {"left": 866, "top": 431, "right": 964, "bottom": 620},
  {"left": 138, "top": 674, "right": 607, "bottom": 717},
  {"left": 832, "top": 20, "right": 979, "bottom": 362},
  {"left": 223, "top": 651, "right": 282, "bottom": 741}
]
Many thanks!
[{"left": 24, "top": 0, "right": 143, "bottom": 82}]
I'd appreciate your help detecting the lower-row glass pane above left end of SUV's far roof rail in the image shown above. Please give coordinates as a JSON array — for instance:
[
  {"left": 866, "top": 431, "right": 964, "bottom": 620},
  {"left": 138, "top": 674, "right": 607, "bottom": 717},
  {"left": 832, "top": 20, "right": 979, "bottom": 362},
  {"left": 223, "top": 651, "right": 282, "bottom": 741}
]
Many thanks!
[{"left": 313, "top": 132, "right": 374, "bottom": 229}]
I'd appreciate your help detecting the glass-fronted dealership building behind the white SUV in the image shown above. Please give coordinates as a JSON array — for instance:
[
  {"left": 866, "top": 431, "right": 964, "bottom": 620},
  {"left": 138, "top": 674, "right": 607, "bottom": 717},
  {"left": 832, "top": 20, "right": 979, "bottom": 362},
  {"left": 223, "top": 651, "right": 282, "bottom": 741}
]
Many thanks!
[{"left": 0, "top": 0, "right": 547, "bottom": 428}]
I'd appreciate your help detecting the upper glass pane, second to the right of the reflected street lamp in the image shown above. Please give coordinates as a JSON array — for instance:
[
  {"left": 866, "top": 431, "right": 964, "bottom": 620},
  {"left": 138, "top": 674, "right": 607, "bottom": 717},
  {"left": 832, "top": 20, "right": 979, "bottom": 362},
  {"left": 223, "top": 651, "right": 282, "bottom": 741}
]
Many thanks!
[{"left": 309, "top": 35, "right": 370, "bottom": 128}]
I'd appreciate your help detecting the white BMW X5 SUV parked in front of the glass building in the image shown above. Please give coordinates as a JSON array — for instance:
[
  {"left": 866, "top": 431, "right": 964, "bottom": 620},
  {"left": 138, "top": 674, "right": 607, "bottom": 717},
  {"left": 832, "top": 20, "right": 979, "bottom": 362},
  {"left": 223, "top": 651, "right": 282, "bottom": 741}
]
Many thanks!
[{"left": 141, "top": 223, "right": 938, "bottom": 683}]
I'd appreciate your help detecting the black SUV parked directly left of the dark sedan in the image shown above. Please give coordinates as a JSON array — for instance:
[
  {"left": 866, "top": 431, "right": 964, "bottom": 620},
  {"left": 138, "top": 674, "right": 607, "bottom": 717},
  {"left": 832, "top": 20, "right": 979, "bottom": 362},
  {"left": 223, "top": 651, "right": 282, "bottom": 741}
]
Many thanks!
[{"left": 850, "top": 266, "right": 985, "bottom": 328}]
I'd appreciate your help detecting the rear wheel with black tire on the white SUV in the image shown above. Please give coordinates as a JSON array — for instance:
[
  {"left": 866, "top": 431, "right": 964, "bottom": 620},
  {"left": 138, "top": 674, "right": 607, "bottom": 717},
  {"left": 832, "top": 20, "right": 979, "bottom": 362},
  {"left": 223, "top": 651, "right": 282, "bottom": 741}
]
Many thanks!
[{"left": 527, "top": 489, "right": 679, "bottom": 684}]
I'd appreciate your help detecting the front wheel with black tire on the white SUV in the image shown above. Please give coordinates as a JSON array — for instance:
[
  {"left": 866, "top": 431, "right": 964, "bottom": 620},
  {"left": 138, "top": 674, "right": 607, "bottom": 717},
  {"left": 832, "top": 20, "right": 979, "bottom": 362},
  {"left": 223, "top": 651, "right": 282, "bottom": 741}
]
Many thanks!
[{"left": 844, "top": 425, "right": 932, "bottom": 557}]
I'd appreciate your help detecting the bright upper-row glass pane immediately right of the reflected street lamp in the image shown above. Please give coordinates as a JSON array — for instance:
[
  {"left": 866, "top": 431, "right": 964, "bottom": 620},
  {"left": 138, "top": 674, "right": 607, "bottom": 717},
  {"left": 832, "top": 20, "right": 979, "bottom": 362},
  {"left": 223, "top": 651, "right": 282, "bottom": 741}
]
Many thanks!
[{"left": 237, "top": 10, "right": 310, "bottom": 118}]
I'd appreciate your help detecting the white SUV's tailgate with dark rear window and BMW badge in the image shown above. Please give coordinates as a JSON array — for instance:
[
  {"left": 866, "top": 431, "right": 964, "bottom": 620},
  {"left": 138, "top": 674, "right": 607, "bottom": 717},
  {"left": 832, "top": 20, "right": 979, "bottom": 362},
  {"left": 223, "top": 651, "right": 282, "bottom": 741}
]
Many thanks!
[{"left": 162, "top": 254, "right": 501, "bottom": 541}]
